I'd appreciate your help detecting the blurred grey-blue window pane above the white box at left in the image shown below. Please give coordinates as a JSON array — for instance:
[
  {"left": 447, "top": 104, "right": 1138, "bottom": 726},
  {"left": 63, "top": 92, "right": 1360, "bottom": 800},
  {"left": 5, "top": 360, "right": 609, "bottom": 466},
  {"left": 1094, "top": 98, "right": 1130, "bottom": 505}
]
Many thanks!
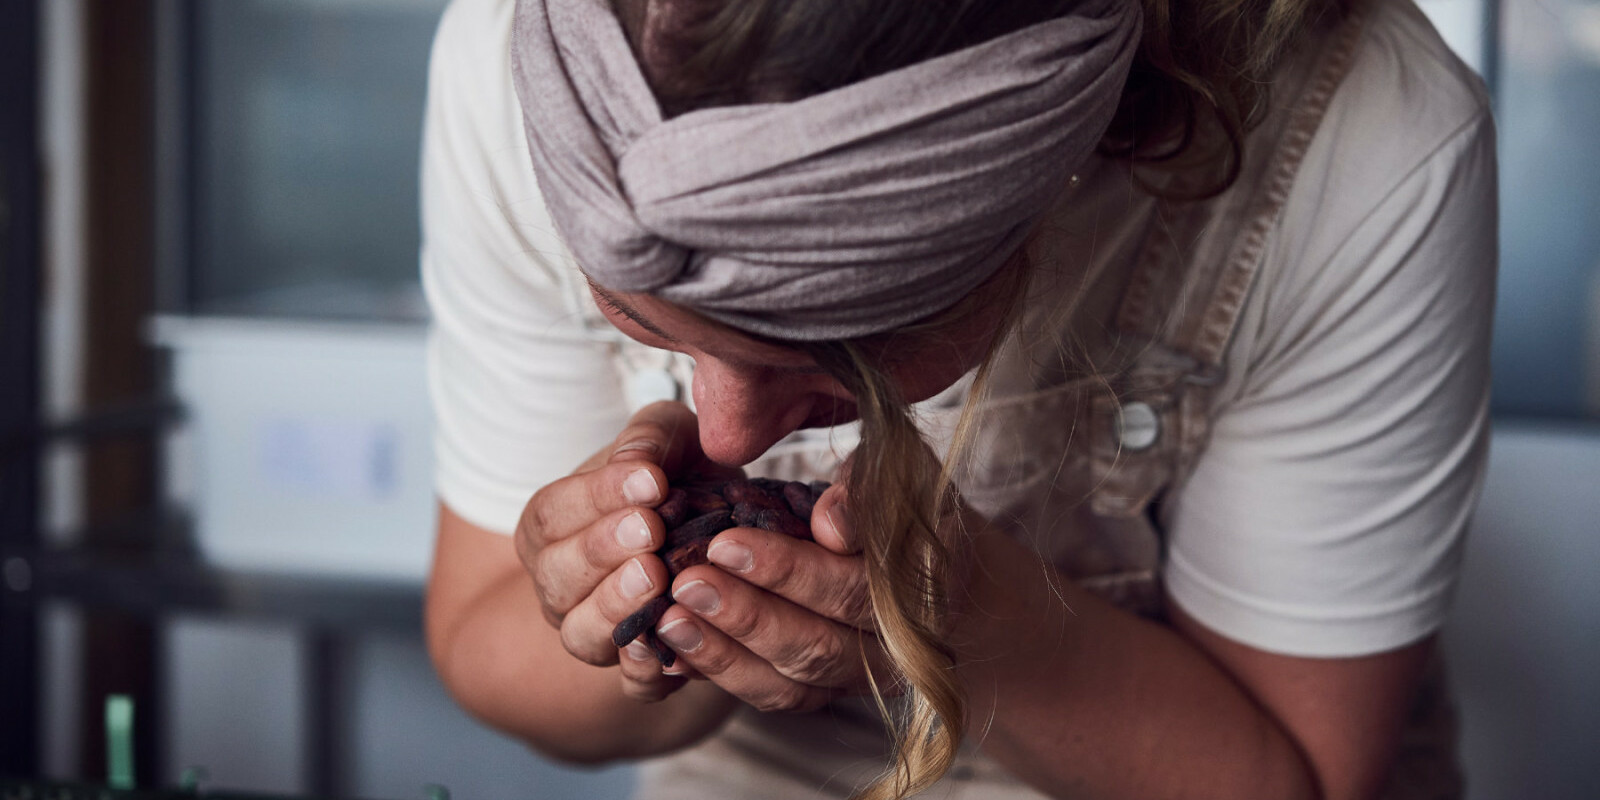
[{"left": 192, "top": 0, "right": 445, "bottom": 318}]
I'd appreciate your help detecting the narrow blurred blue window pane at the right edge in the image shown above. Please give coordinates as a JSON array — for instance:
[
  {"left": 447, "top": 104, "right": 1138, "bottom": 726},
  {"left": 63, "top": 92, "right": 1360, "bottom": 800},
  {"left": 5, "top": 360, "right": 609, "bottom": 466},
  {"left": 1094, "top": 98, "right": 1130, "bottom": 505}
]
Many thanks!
[{"left": 1494, "top": 0, "right": 1600, "bottom": 416}]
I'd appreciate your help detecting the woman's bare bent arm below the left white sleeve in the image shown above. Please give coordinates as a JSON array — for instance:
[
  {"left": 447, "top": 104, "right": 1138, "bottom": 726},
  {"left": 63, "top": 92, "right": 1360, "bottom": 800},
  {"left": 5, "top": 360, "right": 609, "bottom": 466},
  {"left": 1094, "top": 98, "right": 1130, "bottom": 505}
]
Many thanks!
[{"left": 427, "top": 509, "right": 736, "bottom": 763}]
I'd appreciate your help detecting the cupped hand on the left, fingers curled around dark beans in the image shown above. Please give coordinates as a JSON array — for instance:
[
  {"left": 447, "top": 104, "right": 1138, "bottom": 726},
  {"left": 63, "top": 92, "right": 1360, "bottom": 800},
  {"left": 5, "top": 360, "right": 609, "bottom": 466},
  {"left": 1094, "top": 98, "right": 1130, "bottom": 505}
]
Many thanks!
[{"left": 515, "top": 403, "right": 736, "bottom": 701}]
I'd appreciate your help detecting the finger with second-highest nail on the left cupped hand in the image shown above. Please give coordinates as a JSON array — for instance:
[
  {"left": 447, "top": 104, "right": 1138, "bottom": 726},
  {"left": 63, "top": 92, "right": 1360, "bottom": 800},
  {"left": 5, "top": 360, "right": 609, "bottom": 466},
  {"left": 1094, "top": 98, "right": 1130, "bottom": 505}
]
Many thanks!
[{"left": 526, "top": 507, "right": 666, "bottom": 616}]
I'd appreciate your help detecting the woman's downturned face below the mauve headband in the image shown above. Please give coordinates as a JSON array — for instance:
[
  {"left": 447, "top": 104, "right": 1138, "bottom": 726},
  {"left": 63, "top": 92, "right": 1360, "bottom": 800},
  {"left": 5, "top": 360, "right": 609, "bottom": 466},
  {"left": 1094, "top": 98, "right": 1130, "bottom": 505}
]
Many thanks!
[{"left": 590, "top": 285, "right": 1003, "bottom": 466}]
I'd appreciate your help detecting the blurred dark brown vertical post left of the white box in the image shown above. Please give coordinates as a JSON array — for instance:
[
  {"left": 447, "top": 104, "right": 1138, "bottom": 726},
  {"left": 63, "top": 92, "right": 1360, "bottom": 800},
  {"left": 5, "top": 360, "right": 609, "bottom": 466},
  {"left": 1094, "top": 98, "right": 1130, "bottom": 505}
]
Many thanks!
[{"left": 80, "top": 0, "right": 163, "bottom": 787}]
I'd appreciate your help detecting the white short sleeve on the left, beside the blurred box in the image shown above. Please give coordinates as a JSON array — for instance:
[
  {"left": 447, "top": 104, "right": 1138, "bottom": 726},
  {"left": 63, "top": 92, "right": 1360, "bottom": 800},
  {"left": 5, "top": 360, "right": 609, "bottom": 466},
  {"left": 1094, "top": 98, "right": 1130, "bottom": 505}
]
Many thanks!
[{"left": 421, "top": 0, "right": 627, "bottom": 533}]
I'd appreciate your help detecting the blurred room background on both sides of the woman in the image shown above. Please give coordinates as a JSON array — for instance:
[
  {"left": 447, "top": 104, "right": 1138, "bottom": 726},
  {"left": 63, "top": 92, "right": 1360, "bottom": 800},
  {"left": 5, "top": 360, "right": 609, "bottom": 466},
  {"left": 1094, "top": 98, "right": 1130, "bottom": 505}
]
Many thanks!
[{"left": 0, "top": 0, "right": 1600, "bottom": 800}]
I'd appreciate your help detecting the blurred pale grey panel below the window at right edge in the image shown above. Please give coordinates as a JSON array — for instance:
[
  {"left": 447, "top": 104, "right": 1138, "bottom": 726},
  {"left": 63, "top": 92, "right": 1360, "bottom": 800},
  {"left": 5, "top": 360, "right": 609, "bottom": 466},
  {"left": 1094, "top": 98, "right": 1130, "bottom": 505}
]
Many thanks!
[{"left": 1445, "top": 426, "right": 1600, "bottom": 800}]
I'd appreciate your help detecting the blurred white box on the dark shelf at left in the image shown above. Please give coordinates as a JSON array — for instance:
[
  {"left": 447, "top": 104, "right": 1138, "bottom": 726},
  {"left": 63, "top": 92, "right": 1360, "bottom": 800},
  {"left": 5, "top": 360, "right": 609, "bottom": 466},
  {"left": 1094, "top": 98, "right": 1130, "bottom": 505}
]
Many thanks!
[{"left": 155, "top": 318, "right": 435, "bottom": 581}]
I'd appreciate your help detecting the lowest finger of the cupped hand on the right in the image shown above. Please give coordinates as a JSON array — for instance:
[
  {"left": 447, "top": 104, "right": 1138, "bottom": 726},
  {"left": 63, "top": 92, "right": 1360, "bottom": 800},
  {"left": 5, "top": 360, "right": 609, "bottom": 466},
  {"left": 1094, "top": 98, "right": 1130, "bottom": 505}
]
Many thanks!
[{"left": 656, "top": 606, "right": 840, "bottom": 712}]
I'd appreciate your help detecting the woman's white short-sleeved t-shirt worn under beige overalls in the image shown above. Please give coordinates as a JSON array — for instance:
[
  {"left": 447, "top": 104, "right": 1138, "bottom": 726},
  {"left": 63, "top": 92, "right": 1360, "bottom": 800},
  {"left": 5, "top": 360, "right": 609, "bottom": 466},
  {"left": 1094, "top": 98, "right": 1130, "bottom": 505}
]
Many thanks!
[{"left": 422, "top": 0, "right": 1498, "bottom": 656}]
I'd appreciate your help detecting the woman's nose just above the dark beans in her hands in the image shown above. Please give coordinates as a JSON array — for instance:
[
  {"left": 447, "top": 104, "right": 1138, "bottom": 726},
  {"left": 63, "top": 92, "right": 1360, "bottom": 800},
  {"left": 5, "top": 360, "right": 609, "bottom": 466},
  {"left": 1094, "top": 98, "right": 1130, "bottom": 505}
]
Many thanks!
[{"left": 691, "top": 360, "right": 816, "bottom": 467}]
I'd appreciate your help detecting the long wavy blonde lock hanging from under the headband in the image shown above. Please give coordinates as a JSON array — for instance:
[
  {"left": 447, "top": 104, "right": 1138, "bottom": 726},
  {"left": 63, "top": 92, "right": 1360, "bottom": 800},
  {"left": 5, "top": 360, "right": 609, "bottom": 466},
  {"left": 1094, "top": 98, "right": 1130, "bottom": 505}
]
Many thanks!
[{"left": 792, "top": 250, "right": 1029, "bottom": 800}]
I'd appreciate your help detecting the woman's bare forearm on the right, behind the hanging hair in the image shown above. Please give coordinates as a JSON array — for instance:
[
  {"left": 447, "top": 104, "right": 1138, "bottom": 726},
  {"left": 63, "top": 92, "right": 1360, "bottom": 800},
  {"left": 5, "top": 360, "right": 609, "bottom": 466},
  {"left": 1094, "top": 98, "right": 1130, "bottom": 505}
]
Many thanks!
[{"left": 957, "top": 536, "right": 1317, "bottom": 800}]
